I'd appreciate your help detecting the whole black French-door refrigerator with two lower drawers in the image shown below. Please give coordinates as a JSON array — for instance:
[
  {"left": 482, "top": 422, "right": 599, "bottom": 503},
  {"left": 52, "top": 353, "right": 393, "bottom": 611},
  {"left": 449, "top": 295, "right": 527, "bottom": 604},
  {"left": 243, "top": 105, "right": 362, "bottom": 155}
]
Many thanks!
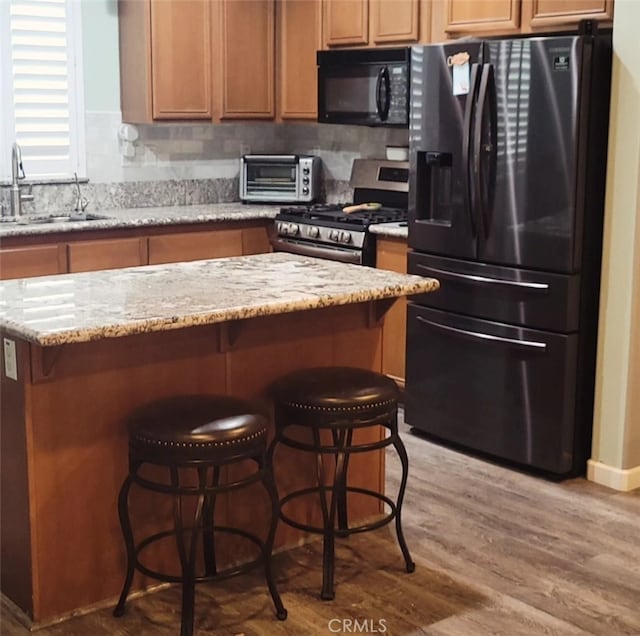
[{"left": 405, "top": 24, "right": 611, "bottom": 478}]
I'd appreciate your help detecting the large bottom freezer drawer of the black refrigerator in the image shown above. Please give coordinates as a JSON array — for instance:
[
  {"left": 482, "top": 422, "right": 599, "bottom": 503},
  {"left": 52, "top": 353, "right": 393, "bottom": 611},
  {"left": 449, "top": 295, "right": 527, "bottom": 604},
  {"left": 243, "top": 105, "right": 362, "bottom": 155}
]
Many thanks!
[{"left": 405, "top": 304, "right": 585, "bottom": 476}]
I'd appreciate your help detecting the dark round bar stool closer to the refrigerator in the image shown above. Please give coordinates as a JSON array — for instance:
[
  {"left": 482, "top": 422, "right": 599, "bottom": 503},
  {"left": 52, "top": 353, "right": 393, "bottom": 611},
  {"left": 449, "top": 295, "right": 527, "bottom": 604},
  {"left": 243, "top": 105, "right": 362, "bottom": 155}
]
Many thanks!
[{"left": 268, "top": 367, "right": 415, "bottom": 600}]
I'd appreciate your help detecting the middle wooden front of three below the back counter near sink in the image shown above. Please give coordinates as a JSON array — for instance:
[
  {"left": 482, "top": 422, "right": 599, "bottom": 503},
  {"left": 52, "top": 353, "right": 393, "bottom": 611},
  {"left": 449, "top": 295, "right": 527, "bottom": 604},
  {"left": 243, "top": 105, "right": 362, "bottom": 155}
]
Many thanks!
[{"left": 67, "top": 237, "right": 148, "bottom": 272}]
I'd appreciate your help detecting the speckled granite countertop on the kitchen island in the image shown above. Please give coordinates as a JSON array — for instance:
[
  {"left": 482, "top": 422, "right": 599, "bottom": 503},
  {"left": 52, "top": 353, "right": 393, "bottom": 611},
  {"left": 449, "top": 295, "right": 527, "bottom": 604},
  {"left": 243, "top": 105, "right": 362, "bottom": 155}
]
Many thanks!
[{"left": 0, "top": 252, "right": 439, "bottom": 346}]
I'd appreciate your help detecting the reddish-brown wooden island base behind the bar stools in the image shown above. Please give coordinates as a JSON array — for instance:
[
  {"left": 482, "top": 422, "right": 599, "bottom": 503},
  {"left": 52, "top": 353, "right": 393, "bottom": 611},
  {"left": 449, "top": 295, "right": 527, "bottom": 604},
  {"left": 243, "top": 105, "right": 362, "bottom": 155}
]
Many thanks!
[{"left": 1, "top": 300, "right": 393, "bottom": 625}]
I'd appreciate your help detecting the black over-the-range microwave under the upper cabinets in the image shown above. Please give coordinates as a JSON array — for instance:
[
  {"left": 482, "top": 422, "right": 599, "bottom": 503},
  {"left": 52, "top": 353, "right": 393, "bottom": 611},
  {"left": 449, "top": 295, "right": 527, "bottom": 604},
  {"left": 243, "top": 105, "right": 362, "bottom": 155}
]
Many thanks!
[{"left": 317, "top": 47, "right": 411, "bottom": 128}]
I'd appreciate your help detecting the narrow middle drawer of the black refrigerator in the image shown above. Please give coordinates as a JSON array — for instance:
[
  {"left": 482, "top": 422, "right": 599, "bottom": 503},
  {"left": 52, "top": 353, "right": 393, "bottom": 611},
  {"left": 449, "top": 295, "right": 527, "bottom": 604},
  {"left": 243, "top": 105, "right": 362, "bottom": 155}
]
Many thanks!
[{"left": 408, "top": 252, "right": 580, "bottom": 333}]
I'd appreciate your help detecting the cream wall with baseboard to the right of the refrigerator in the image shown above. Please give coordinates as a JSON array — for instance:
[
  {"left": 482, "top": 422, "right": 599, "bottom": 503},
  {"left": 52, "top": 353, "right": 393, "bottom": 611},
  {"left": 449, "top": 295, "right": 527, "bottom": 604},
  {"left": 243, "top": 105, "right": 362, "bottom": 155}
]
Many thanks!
[{"left": 589, "top": 0, "right": 640, "bottom": 490}]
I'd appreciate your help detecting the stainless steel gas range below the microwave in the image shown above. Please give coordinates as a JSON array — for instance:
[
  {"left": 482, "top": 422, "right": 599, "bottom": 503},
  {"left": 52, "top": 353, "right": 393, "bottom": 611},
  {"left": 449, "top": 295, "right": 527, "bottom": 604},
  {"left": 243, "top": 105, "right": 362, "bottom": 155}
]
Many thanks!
[{"left": 272, "top": 159, "right": 409, "bottom": 266}]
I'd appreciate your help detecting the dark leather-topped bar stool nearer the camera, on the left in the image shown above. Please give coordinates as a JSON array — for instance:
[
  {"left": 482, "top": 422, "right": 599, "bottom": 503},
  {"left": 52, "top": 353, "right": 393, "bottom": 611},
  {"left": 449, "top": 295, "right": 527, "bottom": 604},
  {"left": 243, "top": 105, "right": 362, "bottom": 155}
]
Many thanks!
[{"left": 113, "top": 395, "right": 287, "bottom": 636}]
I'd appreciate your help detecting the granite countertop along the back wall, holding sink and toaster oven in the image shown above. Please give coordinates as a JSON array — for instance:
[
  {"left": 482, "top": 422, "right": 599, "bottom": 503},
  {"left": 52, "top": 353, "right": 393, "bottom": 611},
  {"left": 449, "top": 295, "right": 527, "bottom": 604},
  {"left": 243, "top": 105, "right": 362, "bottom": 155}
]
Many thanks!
[{"left": 0, "top": 201, "right": 281, "bottom": 238}]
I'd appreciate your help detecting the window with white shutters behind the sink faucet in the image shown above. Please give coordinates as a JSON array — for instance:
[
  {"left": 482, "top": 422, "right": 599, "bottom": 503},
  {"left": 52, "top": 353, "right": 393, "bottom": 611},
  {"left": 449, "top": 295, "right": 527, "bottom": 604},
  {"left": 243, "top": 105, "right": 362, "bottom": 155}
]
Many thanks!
[{"left": 0, "top": 0, "right": 86, "bottom": 180}]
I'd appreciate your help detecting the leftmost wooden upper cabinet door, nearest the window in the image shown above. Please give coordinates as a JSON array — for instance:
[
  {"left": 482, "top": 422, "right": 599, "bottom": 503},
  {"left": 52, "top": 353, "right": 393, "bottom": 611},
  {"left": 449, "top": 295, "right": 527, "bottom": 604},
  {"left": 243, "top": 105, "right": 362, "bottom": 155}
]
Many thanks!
[{"left": 149, "top": 0, "right": 212, "bottom": 119}]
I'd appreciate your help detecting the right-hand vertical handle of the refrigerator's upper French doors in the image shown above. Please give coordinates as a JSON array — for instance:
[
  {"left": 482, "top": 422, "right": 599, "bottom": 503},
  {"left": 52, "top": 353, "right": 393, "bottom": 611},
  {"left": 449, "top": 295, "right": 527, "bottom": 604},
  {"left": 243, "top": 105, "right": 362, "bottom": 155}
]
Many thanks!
[{"left": 472, "top": 64, "right": 496, "bottom": 238}]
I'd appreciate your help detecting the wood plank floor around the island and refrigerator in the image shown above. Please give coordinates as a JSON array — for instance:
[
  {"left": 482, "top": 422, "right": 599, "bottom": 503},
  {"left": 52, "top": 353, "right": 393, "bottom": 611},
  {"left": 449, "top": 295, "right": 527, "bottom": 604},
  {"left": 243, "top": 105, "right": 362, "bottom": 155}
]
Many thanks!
[{"left": 0, "top": 414, "right": 640, "bottom": 636}]
